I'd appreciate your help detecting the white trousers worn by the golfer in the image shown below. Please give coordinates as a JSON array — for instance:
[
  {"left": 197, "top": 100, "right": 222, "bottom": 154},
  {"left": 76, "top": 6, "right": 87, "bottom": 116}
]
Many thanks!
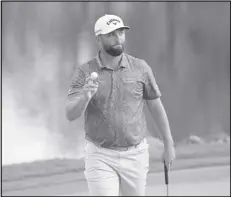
[{"left": 84, "top": 139, "right": 149, "bottom": 196}]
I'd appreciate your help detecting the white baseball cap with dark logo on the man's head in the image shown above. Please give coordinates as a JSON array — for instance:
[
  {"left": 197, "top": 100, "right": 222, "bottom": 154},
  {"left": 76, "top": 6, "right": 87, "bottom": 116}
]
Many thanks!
[{"left": 95, "top": 14, "right": 130, "bottom": 36}]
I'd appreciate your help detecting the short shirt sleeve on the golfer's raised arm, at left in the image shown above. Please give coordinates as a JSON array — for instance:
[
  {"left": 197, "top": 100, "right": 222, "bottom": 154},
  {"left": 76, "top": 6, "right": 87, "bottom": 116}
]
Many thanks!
[{"left": 67, "top": 66, "right": 86, "bottom": 100}]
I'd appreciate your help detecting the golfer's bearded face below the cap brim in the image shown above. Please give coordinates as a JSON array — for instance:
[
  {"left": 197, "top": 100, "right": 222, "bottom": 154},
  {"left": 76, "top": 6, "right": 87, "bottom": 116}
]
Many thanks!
[{"left": 100, "top": 28, "right": 125, "bottom": 56}]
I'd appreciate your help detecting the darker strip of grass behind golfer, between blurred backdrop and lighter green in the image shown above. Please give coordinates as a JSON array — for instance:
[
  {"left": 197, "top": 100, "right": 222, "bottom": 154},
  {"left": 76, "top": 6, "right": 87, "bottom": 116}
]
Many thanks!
[{"left": 2, "top": 144, "right": 230, "bottom": 181}]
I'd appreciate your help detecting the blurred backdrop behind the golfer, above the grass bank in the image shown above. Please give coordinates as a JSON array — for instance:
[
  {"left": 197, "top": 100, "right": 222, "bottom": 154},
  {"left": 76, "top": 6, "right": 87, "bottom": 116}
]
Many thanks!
[{"left": 2, "top": 2, "right": 230, "bottom": 165}]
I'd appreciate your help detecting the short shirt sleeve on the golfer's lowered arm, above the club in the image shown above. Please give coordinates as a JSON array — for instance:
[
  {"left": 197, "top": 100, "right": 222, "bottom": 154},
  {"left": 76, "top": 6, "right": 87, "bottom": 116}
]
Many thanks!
[{"left": 143, "top": 60, "right": 161, "bottom": 100}]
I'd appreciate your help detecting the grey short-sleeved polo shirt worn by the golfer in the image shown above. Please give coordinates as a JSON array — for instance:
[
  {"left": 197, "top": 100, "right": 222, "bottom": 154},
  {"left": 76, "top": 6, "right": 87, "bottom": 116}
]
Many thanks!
[{"left": 68, "top": 53, "right": 161, "bottom": 148}]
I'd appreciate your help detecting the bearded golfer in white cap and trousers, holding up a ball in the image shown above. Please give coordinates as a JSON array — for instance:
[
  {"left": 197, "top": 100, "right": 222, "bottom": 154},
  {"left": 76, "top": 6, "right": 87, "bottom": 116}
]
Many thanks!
[{"left": 66, "top": 15, "right": 175, "bottom": 196}]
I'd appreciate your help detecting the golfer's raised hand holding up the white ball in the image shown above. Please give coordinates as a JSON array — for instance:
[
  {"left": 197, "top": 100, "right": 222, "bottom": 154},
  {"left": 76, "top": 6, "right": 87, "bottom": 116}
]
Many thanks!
[{"left": 82, "top": 77, "right": 99, "bottom": 99}]
